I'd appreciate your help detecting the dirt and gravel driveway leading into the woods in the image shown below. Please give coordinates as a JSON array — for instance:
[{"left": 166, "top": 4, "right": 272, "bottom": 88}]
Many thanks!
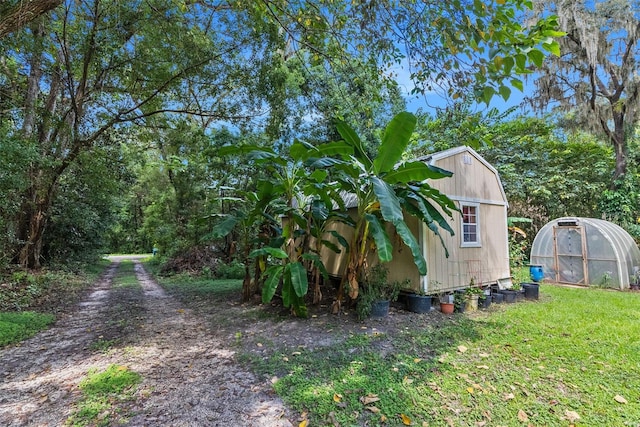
[{"left": 0, "top": 259, "right": 291, "bottom": 427}]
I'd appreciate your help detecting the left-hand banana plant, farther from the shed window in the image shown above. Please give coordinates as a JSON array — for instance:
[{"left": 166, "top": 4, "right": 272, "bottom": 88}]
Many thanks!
[{"left": 221, "top": 143, "right": 344, "bottom": 317}]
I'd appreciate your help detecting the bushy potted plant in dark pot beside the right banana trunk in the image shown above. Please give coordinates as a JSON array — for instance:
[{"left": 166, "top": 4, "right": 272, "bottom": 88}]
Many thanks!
[{"left": 356, "top": 264, "right": 402, "bottom": 320}]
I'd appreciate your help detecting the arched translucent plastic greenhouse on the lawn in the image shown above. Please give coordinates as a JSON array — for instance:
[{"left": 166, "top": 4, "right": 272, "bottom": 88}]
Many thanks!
[{"left": 531, "top": 217, "right": 640, "bottom": 289}]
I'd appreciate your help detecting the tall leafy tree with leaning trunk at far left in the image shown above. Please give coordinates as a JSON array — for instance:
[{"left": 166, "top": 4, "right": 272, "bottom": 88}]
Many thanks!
[{"left": 2, "top": 0, "right": 276, "bottom": 268}]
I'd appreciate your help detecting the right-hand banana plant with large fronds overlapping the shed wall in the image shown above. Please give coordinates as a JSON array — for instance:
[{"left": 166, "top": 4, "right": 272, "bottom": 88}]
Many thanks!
[{"left": 300, "top": 112, "right": 458, "bottom": 311}]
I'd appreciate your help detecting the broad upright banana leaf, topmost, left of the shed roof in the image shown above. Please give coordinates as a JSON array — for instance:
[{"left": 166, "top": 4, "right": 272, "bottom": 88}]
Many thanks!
[{"left": 373, "top": 111, "right": 416, "bottom": 174}]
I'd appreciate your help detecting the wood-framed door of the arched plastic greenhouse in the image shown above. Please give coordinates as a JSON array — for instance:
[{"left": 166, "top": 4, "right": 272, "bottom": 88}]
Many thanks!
[{"left": 553, "top": 226, "right": 589, "bottom": 285}]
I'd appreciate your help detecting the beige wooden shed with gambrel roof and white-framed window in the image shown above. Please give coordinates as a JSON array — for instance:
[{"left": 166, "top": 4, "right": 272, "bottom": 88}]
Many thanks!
[{"left": 322, "top": 146, "right": 510, "bottom": 294}]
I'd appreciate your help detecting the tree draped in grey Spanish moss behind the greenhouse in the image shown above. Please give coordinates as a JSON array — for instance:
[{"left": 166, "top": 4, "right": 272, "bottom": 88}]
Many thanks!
[{"left": 532, "top": 0, "right": 640, "bottom": 182}]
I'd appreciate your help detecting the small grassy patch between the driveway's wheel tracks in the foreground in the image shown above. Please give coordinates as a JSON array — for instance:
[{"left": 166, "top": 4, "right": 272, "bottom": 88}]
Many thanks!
[{"left": 66, "top": 365, "right": 142, "bottom": 427}]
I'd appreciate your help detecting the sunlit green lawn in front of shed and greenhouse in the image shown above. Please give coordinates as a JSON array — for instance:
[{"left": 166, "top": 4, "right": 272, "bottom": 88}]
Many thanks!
[{"left": 245, "top": 285, "right": 640, "bottom": 426}]
